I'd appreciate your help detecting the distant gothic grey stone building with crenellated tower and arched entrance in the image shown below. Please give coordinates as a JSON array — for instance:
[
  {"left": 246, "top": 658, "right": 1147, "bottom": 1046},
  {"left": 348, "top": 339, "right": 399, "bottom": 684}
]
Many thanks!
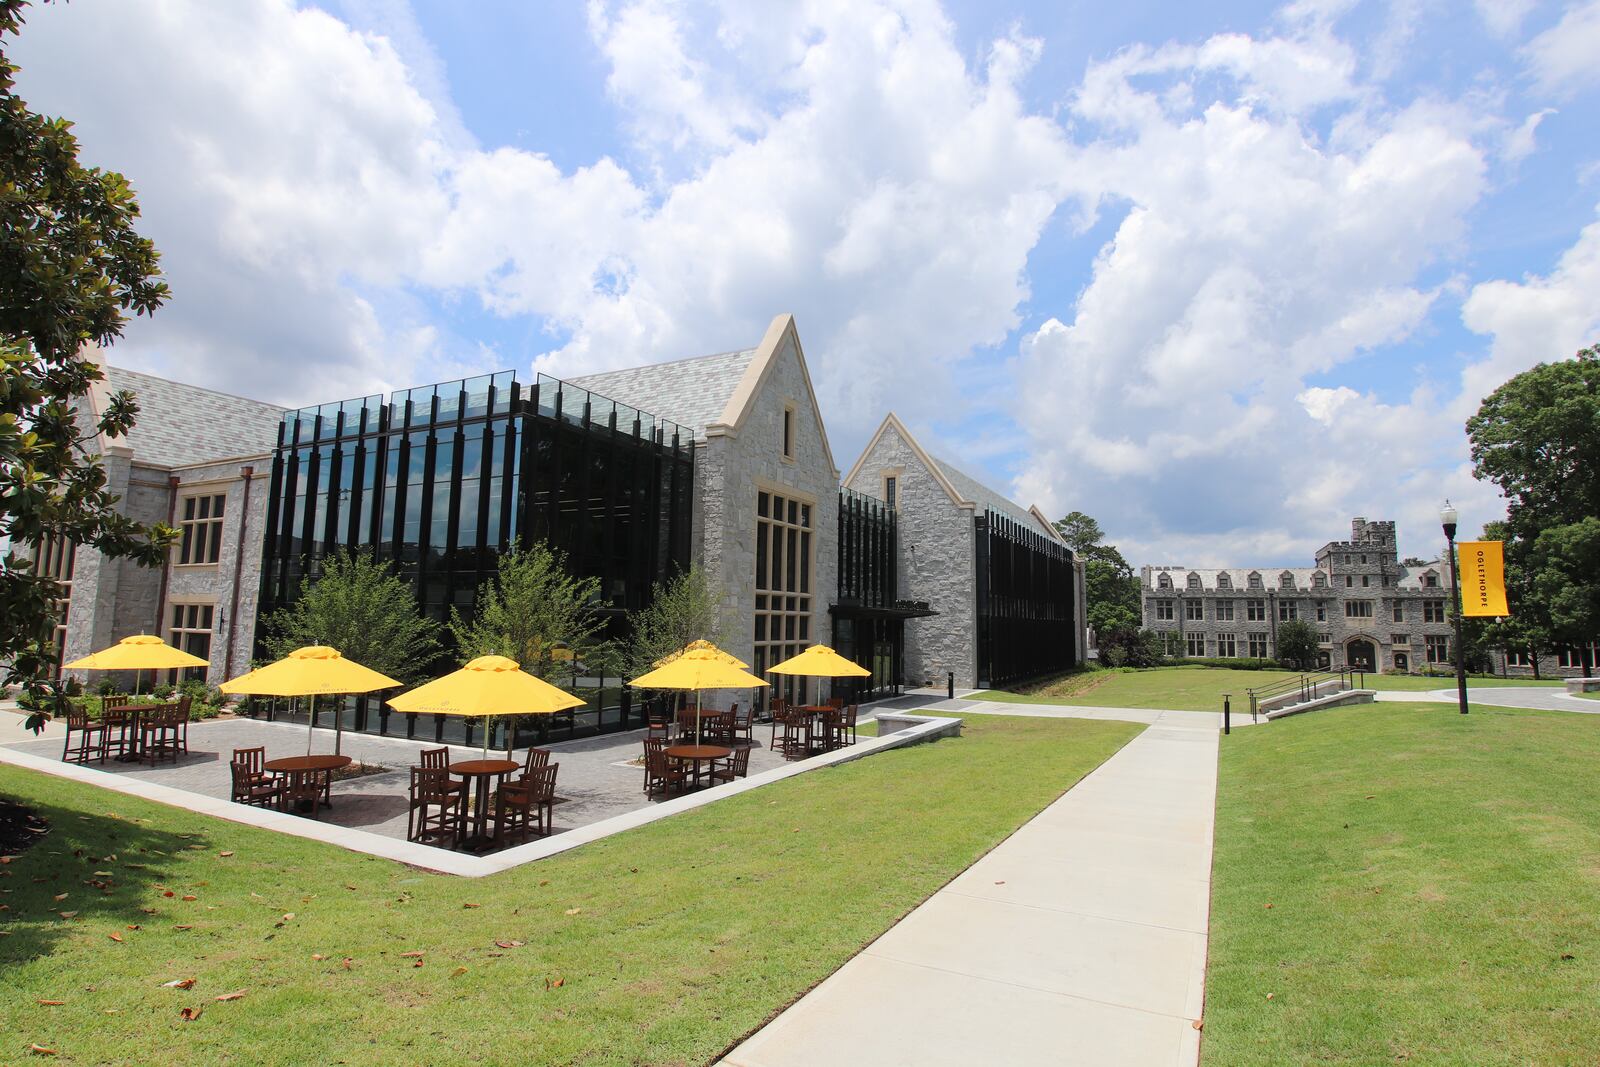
[{"left": 1141, "top": 518, "right": 1451, "bottom": 672}]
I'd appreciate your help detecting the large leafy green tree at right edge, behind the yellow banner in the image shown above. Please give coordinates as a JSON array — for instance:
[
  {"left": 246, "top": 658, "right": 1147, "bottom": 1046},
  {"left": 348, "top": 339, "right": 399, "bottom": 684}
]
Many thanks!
[{"left": 1467, "top": 347, "right": 1600, "bottom": 675}]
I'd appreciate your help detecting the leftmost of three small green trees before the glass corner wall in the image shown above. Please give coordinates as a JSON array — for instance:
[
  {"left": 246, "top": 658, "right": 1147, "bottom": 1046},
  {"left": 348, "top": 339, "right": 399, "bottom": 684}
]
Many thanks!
[{"left": 266, "top": 549, "right": 443, "bottom": 752}]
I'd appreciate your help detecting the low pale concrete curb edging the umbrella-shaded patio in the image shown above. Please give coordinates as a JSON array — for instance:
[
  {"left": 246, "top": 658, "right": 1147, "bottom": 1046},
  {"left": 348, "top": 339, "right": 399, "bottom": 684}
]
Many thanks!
[{"left": 0, "top": 715, "right": 960, "bottom": 878}]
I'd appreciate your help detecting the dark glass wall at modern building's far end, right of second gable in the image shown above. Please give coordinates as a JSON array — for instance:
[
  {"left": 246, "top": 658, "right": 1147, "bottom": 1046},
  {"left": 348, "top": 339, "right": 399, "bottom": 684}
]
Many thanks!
[{"left": 973, "top": 510, "right": 1078, "bottom": 689}]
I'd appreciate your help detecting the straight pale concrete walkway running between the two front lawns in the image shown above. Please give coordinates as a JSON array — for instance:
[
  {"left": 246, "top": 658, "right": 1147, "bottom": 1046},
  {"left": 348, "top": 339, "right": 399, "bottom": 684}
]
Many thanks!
[{"left": 723, "top": 701, "right": 1218, "bottom": 1067}]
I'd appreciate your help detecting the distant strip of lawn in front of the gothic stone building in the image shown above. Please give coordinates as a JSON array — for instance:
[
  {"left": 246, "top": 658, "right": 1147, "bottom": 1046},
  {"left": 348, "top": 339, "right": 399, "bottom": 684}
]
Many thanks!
[{"left": 971, "top": 667, "right": 1562, "bottom": 712}]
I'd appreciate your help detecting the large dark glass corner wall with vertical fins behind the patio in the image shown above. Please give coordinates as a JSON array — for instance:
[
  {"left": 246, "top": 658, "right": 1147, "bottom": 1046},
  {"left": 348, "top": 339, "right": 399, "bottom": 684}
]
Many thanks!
[{"left": 258, "top": 371, "right": 694, "bottom": 744}]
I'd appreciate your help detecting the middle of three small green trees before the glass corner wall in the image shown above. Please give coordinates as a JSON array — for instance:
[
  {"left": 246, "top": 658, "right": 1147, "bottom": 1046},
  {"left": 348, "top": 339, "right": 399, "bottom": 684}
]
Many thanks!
[{"left": 450, "top": 541, "right": 614, "bottom": 681}]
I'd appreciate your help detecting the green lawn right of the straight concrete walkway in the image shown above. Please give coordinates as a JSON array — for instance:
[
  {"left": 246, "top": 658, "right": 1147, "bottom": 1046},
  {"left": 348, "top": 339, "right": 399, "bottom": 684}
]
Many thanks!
[{"left": 1203, "top": 704, "right": 1600, "bottom": 1067}]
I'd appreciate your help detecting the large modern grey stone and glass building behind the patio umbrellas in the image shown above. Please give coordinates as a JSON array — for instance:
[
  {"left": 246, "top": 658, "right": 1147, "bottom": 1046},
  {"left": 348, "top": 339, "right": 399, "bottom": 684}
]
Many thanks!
[{"left": 42, "top": 315, "right": 1083, "bottom": 739}]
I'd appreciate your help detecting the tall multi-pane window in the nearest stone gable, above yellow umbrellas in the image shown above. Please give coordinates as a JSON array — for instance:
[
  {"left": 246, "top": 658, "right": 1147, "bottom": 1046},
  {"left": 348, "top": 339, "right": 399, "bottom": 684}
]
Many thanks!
[{"left": 755, "top": 493, "right": 813, "bottom": 699}]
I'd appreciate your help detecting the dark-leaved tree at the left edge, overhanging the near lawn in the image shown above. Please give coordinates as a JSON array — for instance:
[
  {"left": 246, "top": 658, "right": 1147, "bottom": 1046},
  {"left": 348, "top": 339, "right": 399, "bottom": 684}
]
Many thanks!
[{"left": 0, "top": 0, "right": 176, "bottom": 726}]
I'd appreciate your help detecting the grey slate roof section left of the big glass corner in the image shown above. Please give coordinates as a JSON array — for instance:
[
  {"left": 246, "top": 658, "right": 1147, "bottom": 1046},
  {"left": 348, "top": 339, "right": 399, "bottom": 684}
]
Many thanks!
[{"left": 104, "top": 366, "right": 285, "bottom": 467}]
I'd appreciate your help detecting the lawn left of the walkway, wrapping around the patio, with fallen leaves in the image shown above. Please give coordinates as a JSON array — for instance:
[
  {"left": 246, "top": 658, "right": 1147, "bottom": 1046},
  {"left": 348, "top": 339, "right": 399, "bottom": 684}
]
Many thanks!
[{"left": 0, "top": 717, "right": 1139, "bottom": 1065}]
